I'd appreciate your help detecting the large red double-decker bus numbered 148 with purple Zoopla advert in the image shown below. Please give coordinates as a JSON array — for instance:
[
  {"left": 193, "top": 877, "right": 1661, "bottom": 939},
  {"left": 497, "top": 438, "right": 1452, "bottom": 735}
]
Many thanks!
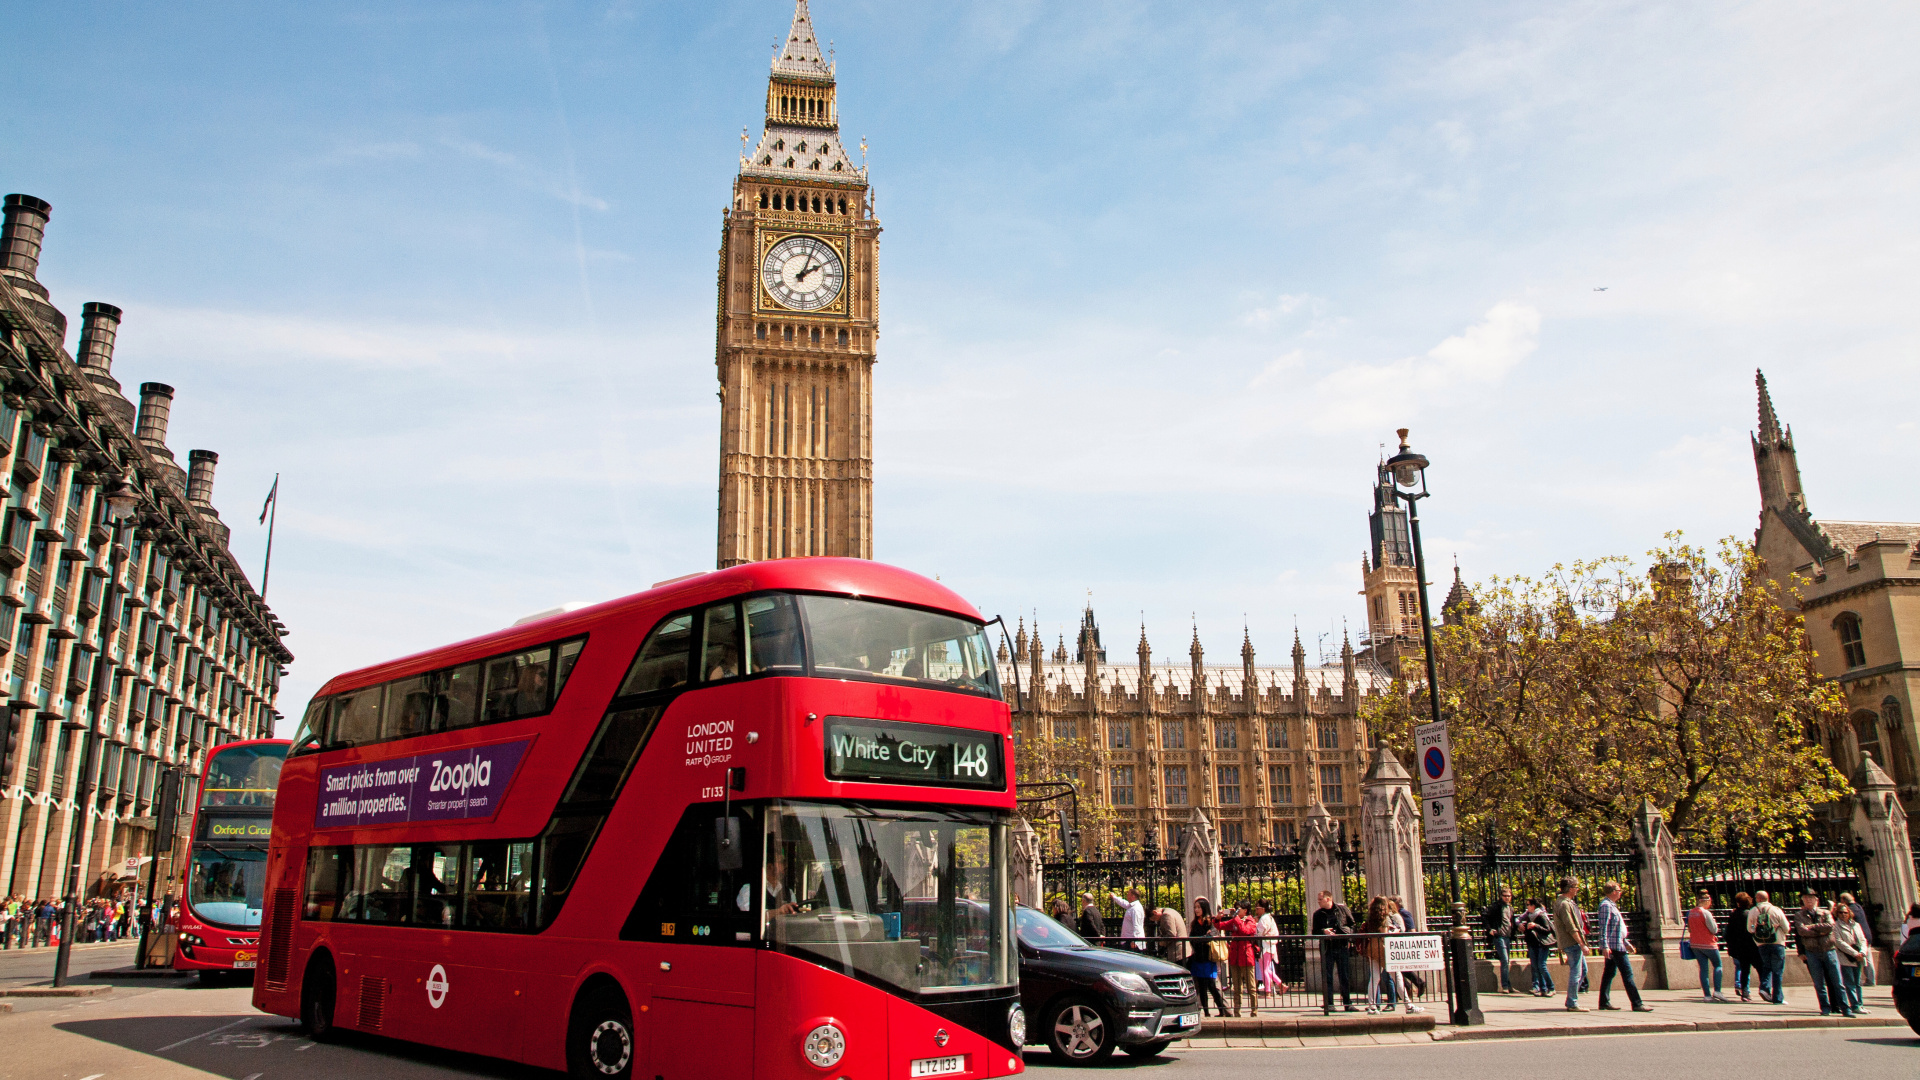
[{"left": 253, "top": 559, "right": 1025, "bottom": 1080}]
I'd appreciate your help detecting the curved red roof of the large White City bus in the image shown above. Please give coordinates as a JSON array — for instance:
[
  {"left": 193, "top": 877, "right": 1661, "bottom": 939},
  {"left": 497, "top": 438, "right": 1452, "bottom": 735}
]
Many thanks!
[{"left": 315, "top": 557, "right": 981, "bottom": 698}]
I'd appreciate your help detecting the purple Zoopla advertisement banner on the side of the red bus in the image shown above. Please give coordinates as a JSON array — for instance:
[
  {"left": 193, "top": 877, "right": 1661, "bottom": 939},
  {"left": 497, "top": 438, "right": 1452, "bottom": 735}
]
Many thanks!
[{"left": 313, "top": 738, "right": 534, "bottom": 828}]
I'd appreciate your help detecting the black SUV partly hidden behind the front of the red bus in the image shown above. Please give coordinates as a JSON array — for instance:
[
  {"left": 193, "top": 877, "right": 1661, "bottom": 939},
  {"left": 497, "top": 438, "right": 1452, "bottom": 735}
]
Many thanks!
[{"left": 1014, "top": 907, "right": 1200, "bottom": 1065}]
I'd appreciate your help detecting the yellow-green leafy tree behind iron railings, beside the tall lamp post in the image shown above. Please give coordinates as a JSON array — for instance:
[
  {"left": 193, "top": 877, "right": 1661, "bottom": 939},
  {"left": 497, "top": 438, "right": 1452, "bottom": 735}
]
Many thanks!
[{"left": 1369, "top": 534, "right": 1847, "bottom": 844}]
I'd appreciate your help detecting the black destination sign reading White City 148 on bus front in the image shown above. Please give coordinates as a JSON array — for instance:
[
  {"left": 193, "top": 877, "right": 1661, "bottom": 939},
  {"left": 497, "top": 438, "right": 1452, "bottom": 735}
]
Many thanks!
[{"left": 828, "top": 717, "right": 1006, "bottom": 792}]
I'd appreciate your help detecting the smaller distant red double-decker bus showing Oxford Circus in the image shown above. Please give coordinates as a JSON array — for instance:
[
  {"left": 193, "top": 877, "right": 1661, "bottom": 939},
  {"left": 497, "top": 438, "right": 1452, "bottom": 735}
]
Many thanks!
[{"left": 173, "top": 738, "right": 290, "bottom": 978}]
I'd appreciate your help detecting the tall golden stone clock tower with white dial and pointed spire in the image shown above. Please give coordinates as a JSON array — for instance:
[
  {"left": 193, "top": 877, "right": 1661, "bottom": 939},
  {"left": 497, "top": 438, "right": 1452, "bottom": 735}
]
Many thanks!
[{"left": 714, "top": 0, "right": 879, "bottom": 567}]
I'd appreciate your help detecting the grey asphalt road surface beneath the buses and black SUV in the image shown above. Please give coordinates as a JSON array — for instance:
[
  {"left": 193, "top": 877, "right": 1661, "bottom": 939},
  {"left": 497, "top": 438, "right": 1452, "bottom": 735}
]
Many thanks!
[{"left": 0, "top": 982, "right": 1920, "bottom": 1080}]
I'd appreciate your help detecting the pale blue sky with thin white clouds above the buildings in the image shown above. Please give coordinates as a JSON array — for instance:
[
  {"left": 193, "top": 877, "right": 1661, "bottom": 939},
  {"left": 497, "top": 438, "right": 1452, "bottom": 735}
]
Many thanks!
[{"left": 0, "top": 0, "right": 1920, "bottom": 715}]
